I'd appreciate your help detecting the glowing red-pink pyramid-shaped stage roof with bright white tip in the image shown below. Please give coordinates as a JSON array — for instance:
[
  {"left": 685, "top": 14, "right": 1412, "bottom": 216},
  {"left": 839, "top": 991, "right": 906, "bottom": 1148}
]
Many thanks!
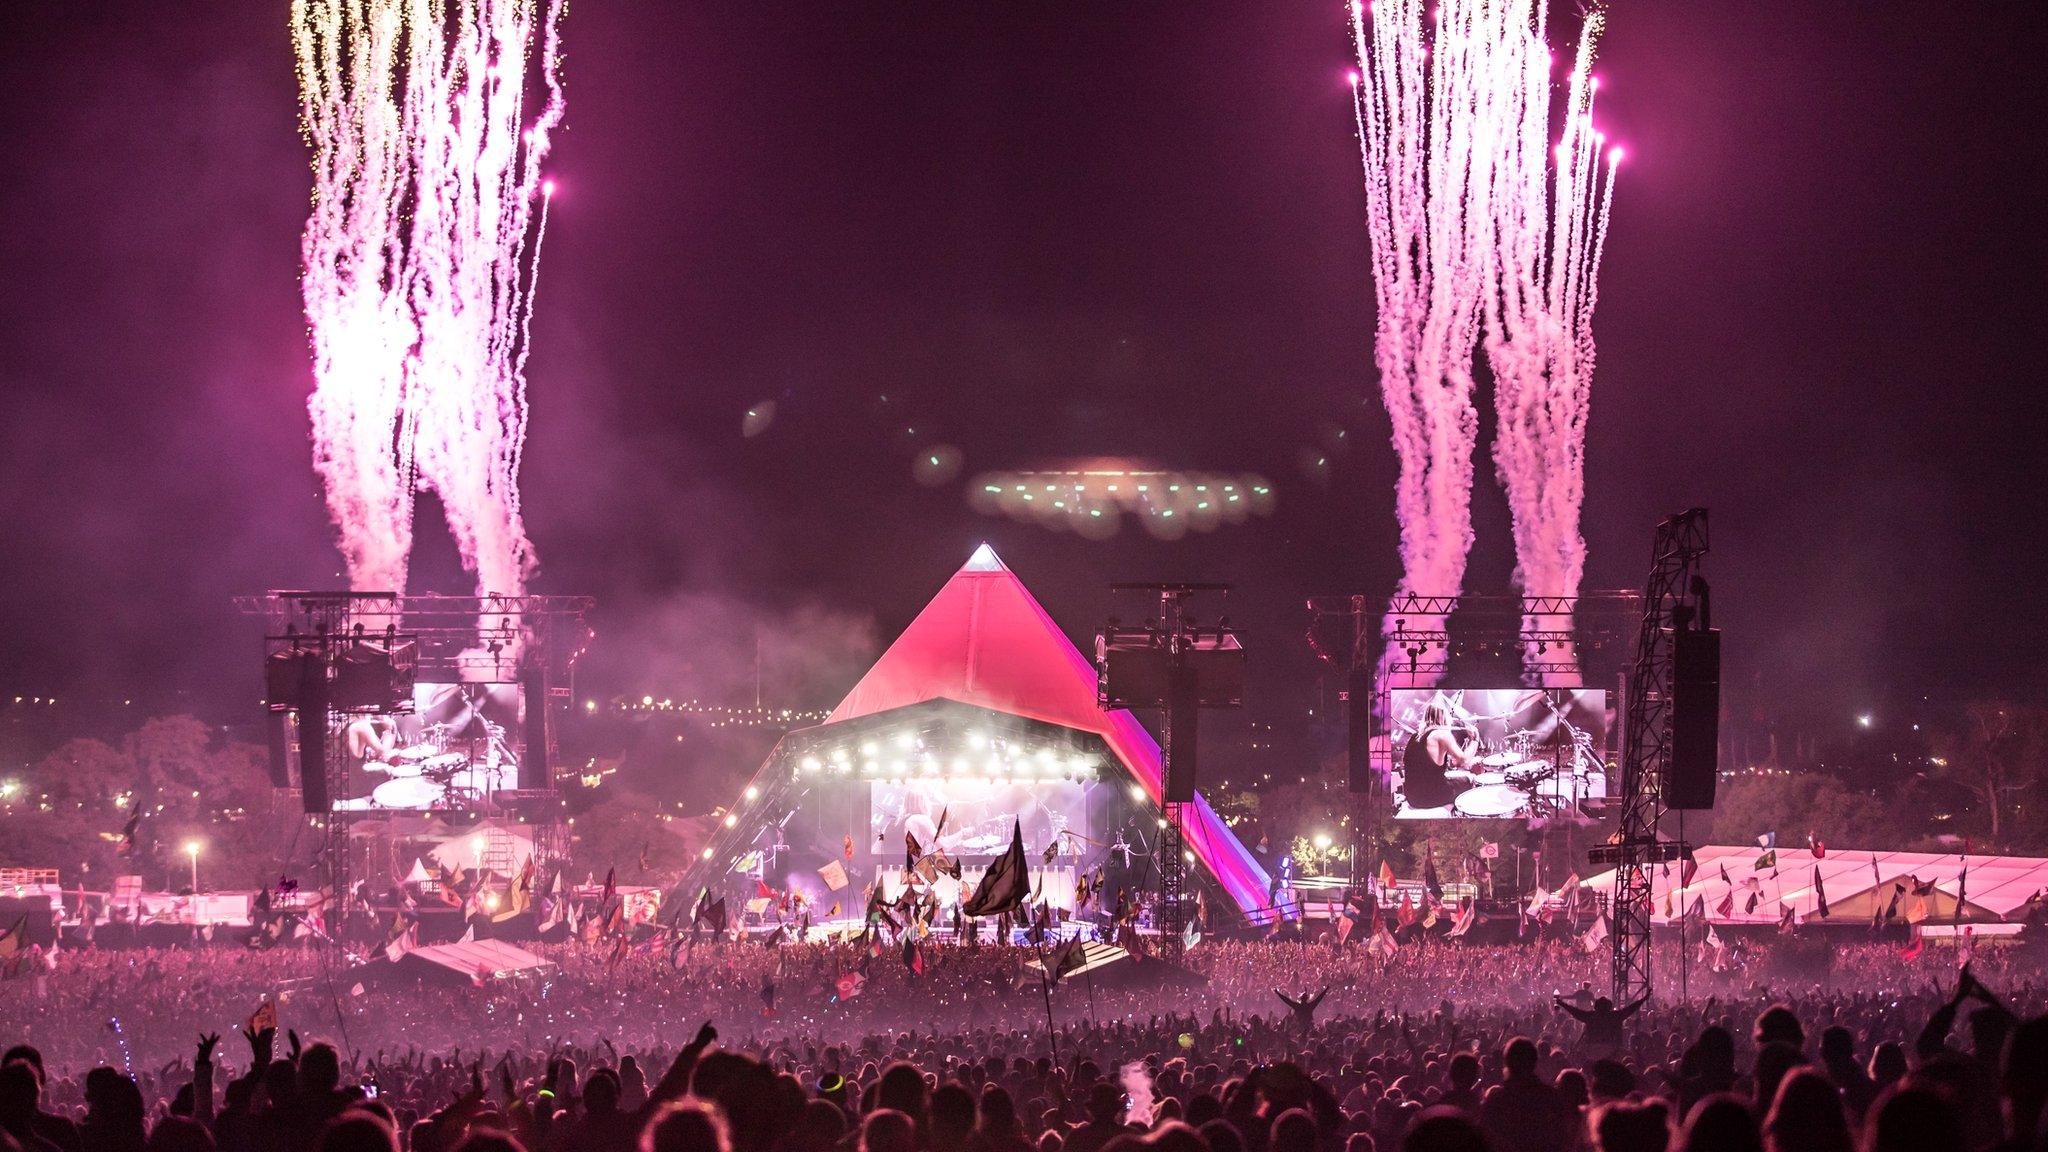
[{"left": 825, "top": 543, "right": 1268, "bottom": 910}]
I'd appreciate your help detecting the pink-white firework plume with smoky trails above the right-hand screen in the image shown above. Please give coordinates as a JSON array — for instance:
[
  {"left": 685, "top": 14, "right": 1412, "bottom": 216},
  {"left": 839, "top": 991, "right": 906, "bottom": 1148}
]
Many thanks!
[{"left": 1352, "top": 0, "right": 1612, "bottom": 680}]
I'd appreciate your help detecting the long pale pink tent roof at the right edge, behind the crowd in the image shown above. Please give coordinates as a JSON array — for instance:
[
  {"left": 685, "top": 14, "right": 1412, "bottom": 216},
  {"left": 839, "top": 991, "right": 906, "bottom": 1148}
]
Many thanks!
[{"left": 1585, "top": 845, "right": 2048, "bottom": 924}]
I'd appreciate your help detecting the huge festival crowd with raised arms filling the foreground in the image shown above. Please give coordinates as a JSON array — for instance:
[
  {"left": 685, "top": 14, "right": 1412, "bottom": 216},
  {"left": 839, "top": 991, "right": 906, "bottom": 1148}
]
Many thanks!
[{"left": 0, "top": 941, "right": 2048, "bottom": 1152}]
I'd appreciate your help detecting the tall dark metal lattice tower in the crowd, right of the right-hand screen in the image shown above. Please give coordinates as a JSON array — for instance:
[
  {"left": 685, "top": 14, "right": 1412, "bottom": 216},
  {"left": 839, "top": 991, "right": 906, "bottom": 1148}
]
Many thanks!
[{"left": 1587, "top": 508, "right": 1706, "bottom": 1004}]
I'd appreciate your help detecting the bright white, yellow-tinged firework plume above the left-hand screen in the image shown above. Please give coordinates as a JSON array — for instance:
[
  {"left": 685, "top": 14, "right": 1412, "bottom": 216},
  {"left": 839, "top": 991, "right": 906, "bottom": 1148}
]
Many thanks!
[{"left": 293, "top": 0, "right": 563, "bottom": 594}]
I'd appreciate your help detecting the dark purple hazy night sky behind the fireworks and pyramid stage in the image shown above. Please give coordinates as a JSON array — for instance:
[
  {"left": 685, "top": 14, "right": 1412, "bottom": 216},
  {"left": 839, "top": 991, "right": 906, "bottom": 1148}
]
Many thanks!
[{"left": 0, "top": 0, "right": 2048, "bottom": 722}]
